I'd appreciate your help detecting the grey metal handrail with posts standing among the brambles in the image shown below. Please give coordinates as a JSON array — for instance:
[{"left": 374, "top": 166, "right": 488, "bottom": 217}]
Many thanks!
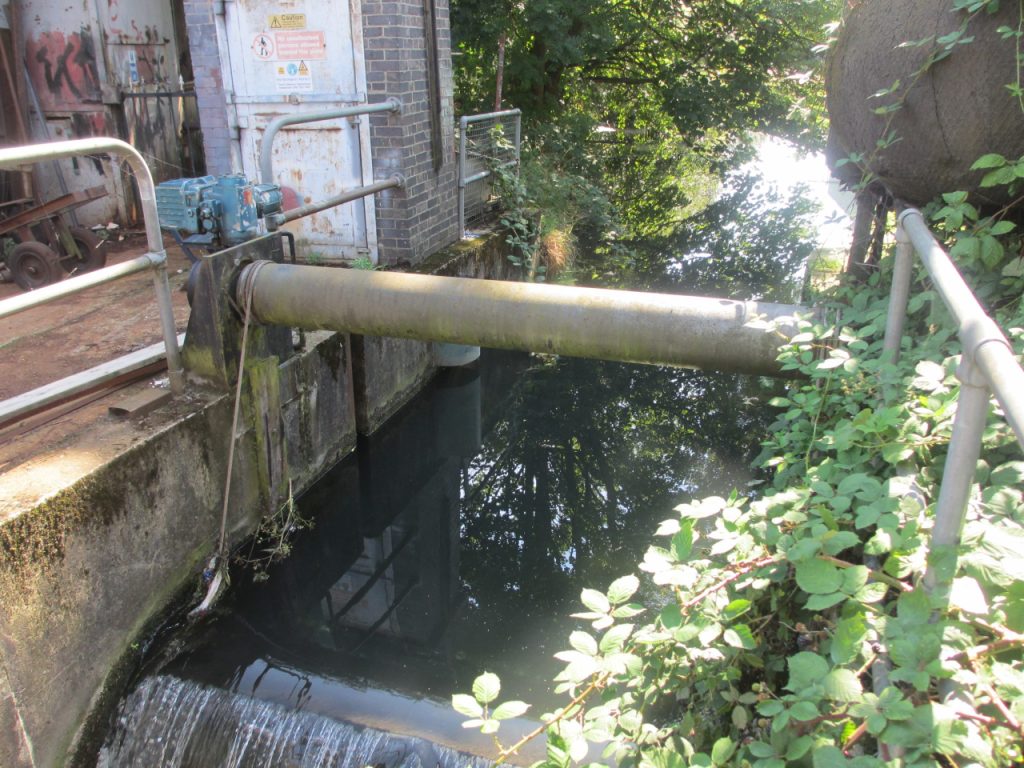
[{"left": 884, "top": 208, "right": 1024, "bottom": 591}]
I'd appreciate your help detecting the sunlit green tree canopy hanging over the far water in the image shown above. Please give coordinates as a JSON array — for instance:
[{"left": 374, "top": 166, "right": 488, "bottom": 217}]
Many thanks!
[{"left": 452, "top": 0, "right": 839, "bottom": 237}]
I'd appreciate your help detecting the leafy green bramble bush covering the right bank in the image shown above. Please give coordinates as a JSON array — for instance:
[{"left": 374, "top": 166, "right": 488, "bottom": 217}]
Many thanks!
[{"left": 453, "top": 225, "right": 1024, "bottom": 768}]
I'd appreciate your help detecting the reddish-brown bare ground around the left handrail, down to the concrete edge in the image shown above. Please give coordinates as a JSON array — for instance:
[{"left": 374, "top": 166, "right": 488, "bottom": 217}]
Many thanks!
[{"left": 0, "top": 233, "right": 195, "bottom": 520}]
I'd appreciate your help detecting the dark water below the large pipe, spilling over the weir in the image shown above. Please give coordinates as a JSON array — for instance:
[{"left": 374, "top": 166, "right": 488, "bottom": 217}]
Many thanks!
[{"left": 104, "top": 352, "right": 768, "bottom": 768}]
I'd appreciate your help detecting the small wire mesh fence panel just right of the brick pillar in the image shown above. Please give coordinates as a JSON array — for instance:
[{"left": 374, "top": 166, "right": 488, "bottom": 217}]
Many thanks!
[{"left": 460, "top": 110, "right": 519, "bottom": 234}]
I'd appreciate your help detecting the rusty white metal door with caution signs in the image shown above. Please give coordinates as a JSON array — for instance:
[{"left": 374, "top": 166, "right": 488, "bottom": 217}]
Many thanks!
[{"left": 221, "top": 0, "right": 377, "bottom": 262}]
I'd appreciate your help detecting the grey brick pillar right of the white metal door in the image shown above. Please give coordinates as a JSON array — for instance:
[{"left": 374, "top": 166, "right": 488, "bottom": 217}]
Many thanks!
[{"left": 362, "top": 0, "right": 459, "bottom": 264}]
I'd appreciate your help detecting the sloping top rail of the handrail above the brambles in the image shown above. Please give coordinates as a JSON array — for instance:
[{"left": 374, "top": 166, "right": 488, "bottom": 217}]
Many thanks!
[{"left": 897, "top": 208, "right": 1024, "bottom": 447}]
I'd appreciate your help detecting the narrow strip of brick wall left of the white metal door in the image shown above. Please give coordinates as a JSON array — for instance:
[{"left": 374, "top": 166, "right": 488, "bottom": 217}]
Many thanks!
[{"left": 184, "top": 0, "right": 231, "bottom": 175}]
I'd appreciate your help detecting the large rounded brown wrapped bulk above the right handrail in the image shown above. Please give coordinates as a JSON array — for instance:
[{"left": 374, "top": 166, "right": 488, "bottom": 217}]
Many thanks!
[{"left": 825, "top": 0, "right": 1024, "bottom": 205}]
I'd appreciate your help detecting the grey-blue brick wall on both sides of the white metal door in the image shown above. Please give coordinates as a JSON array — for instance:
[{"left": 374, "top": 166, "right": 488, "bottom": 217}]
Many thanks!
[{"left": 184, "top": 0, "right": 458, "bottom": 264}]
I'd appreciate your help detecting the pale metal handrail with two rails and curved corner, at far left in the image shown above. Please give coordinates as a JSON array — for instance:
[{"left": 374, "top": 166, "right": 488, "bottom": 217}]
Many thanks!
[{"left": 0, "top": 137, "right": 184, "bottom": 394}]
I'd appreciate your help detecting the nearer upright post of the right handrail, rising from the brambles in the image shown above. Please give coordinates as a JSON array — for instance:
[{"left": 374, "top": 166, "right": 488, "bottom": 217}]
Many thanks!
[{"left": 925, "top": 357, "right": 989, "bottom": 593}]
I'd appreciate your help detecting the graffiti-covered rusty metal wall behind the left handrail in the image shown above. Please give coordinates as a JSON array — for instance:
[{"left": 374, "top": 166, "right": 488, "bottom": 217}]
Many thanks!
[{"left": 11, "top": 0, "right": 190, "bottom": 223}]
